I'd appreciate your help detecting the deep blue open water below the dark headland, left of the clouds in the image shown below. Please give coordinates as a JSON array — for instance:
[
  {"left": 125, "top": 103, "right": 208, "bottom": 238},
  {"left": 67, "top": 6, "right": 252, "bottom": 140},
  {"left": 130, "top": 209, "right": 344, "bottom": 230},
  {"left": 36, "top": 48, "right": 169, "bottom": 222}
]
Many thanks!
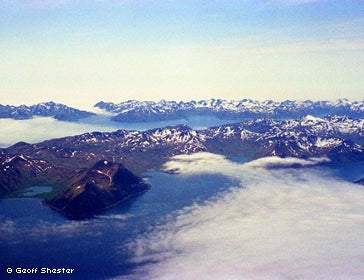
[{"left": 0, "top": 172, "right": 234, "bottom": 279}]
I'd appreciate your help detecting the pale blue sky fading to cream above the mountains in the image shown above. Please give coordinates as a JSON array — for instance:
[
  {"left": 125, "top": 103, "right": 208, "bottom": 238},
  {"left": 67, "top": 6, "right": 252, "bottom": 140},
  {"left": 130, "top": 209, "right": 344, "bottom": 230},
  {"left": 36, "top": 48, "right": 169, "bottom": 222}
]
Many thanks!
[{"left": 0, "top": 0, "right": 364, "bottom": 107}]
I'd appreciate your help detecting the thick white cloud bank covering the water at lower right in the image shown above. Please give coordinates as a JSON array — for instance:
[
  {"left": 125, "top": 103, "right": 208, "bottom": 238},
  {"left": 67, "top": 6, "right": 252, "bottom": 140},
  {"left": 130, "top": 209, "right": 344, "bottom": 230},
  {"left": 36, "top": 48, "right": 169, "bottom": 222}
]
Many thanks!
[{"left": 120, "top": 153, "right": 364, "bottom": 279}]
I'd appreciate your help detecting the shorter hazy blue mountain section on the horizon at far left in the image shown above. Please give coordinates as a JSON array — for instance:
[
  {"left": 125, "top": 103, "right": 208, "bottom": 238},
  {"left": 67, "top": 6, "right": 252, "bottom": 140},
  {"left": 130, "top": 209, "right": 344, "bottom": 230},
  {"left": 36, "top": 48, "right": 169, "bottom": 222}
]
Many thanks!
[{"left": 0, "top": 102, "right": 94, "bottom": 121}]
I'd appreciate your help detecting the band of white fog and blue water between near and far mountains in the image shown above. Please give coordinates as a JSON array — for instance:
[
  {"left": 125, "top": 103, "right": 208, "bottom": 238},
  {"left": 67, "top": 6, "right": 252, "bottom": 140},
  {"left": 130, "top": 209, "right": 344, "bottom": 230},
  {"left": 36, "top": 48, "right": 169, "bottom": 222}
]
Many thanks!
[{"left": 0, "top": 114, "right": 230, "bottom": 148}]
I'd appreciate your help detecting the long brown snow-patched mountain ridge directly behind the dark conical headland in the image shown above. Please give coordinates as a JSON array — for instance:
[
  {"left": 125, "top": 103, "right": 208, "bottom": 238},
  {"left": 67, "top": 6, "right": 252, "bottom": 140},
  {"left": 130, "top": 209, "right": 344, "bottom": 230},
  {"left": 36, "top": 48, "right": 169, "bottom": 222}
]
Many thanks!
[{"left": 0, "top": 116, "right": 364, "bottom": 196}]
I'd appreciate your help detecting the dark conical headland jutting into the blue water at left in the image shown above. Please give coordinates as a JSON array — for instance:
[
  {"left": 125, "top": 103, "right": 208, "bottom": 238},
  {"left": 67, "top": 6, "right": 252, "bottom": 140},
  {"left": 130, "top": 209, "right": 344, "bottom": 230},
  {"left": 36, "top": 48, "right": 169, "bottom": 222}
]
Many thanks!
[{"left": 44, "top": 160, "right": 149, "bottom": 219}]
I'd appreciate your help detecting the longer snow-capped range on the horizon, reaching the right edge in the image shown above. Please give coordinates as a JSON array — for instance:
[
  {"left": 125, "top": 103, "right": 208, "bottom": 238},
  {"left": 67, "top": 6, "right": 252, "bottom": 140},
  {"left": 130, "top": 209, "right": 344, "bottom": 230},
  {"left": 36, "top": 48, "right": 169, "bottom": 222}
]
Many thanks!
[{"left": 95, "top": 99, "right": 364, "bottom": 122}]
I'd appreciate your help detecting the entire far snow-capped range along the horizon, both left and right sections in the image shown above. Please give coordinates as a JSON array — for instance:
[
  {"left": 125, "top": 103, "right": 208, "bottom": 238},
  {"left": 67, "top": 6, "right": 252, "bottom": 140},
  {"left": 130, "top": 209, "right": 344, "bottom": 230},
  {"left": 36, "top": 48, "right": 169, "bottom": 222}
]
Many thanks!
[{"left": 0, "top": 99, "right": 364, "bottom": 123}]
